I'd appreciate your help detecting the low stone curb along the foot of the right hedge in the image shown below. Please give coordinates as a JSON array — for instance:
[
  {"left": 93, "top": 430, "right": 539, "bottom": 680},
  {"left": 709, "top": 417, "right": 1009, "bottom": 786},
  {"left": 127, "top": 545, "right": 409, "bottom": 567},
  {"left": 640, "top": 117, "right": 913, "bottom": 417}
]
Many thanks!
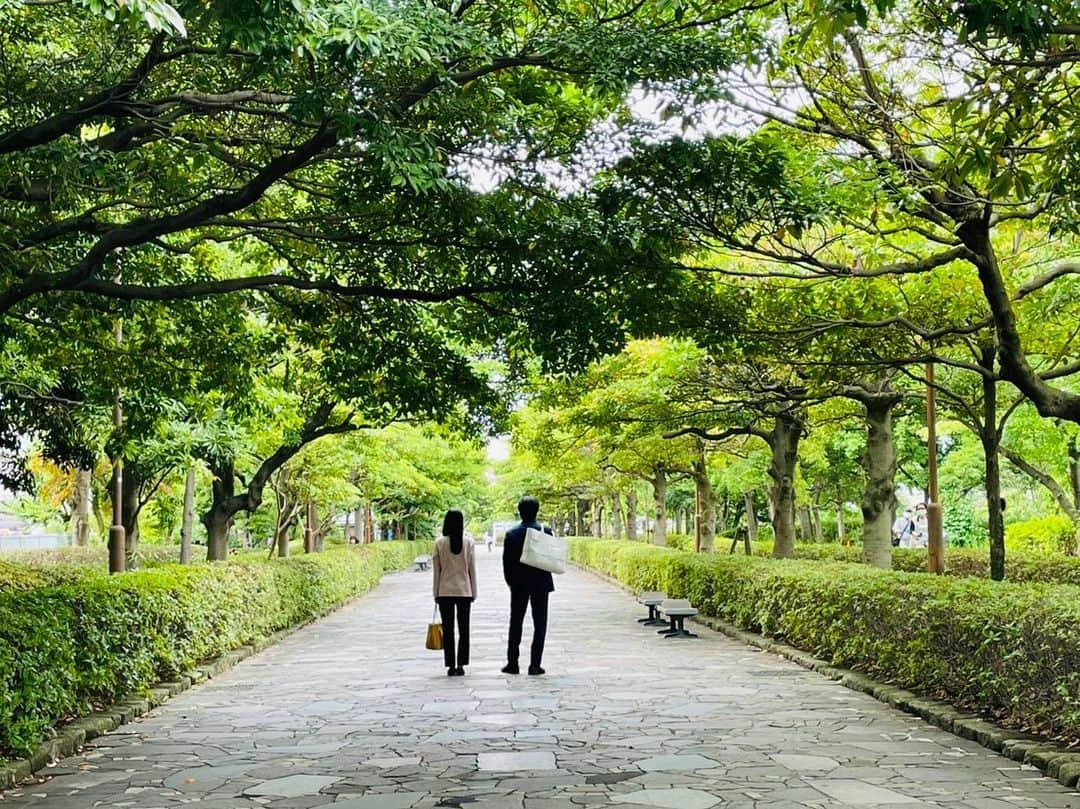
[{"left": 571, "top": 562, "right": 1080, "bottom": 787}]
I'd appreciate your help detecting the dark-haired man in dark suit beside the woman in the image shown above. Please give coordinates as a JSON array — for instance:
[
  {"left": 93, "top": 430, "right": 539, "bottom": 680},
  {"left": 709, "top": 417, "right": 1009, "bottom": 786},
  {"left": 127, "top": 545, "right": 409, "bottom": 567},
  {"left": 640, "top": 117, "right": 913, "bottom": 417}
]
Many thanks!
[{"left": 502, "top": 497, "right": 555, "bottom": 674}]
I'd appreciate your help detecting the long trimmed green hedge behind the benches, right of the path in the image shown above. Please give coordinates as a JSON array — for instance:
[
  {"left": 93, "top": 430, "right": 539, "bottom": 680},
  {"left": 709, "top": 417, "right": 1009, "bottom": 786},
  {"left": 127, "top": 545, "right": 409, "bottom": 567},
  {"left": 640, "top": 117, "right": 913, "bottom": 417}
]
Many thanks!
[{"left": 570, "top": 539, "right": 1080, "bottom": 739}]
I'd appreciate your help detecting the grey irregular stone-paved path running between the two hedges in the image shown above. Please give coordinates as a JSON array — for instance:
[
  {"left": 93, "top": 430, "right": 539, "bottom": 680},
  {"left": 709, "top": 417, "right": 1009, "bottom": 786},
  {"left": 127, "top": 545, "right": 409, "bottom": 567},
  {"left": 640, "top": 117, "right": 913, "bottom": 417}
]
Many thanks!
[{"left": 0, "top": 549, "right": 1080, "bottom": 809}]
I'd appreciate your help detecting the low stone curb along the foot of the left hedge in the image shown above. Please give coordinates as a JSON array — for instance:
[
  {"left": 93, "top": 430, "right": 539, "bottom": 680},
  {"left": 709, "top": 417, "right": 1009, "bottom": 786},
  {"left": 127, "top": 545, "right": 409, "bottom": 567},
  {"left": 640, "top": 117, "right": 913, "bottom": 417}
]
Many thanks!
[{"left": 0, "top": 593, "right": 341, "bottom": 799}]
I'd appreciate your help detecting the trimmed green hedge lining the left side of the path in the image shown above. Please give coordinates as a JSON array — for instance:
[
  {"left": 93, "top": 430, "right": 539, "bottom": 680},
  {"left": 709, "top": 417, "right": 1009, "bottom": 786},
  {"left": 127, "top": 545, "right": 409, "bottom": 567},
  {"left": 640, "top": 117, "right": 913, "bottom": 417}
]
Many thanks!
[{"left": 0, "top": 542, "right": 416, "bottom": 756}]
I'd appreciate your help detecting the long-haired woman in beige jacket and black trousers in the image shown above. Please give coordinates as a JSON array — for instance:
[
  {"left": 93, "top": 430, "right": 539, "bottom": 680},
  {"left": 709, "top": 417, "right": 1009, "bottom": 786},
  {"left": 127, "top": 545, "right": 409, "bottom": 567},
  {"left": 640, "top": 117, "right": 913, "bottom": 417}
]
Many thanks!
[{"left": 431, "top": 510, "right": 476, "bottom": 677}]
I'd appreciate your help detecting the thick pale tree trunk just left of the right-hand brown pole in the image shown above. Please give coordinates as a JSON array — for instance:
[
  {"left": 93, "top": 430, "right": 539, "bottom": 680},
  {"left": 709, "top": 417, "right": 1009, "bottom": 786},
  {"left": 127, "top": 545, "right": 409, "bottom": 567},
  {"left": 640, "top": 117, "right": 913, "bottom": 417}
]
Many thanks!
[{"left": 861, "top": 394, "right": 899, "bottom": 570}]
